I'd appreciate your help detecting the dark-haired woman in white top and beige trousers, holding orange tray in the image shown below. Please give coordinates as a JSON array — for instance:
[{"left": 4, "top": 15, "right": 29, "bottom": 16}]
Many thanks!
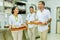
[{"left": 9, "top": 6, "right": 23, "bottom": 40}]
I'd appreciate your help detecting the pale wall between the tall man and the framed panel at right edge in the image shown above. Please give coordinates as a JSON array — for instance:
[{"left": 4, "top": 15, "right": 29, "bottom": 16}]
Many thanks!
[{"left": 45, "top": 0, "right": 60, "bottom": 33}]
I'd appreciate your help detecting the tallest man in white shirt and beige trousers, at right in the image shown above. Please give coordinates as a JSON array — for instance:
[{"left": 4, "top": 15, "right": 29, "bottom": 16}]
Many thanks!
[{"left": 36, "top": 1, "right": 51, "bottom": 40}]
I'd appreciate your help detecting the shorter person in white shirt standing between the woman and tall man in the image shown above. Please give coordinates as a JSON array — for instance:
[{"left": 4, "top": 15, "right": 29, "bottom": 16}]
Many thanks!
[{"left": 26, "top": 6, "right": 35, "bottom": 40}]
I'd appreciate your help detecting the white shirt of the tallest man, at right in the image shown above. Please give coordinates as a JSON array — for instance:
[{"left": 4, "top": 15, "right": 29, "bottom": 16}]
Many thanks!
[{"left": 36, "top": 9, "right": 51, "bottom": 32}]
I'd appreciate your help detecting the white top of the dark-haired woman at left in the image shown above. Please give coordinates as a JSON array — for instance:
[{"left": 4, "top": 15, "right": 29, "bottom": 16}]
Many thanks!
[{"left": 9, "top": 14, "right": 23, "bottom": 27}]
